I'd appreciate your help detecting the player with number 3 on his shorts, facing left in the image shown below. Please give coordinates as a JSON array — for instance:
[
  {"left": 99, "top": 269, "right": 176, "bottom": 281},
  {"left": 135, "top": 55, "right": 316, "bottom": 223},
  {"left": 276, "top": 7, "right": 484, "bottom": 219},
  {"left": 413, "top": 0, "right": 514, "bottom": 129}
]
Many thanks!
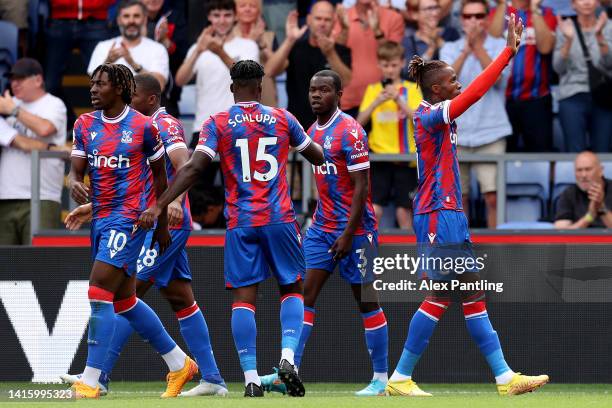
[{"left": 262, "top": 70, "right": 389, "bottom": 396}]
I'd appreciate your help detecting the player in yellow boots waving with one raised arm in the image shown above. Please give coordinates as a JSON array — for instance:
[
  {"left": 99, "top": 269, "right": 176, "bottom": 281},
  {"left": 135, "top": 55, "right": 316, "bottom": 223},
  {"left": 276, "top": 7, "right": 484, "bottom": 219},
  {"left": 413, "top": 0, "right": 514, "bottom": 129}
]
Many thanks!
[{"left": 386, "top": 14, "right": 548, "bottom": 396}]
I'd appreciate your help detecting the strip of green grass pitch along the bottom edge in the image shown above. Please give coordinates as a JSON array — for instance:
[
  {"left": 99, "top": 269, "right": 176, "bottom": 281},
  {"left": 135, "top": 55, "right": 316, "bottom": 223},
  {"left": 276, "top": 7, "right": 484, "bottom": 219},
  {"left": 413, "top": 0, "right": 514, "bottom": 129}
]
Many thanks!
[{"left": 0, "top": 382, "right": 612, "bottom": 408}]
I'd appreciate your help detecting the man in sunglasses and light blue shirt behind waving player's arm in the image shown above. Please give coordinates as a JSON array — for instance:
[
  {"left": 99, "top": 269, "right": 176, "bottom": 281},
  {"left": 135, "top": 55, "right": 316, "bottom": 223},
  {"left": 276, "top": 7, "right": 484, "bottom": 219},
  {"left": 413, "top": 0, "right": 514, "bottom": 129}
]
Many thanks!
[{"left": 440, "top": 0, "right": 512, "bottom": 228}]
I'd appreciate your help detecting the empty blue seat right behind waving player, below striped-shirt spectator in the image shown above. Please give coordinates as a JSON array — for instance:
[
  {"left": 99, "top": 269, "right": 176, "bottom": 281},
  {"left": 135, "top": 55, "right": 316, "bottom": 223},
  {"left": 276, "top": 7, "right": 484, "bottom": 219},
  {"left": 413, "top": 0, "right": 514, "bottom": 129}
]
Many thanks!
[{"left": 506, "top": 161, "right": 550, "bottom": 221}]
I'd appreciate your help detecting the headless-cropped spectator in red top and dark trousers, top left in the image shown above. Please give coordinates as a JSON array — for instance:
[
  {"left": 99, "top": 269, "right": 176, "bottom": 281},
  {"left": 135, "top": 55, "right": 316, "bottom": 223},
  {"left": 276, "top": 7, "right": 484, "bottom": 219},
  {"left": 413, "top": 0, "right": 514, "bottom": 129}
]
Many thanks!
[{"left": 45, "top": 0, "right": 116, "bottom": 123}]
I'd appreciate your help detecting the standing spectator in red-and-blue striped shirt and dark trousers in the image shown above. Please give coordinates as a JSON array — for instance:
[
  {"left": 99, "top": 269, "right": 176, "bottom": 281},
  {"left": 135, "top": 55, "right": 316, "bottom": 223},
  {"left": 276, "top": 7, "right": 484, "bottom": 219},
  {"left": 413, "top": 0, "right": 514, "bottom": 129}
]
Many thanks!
[{"left": 489, "top": 0, "right": 557, "bottom": 152}]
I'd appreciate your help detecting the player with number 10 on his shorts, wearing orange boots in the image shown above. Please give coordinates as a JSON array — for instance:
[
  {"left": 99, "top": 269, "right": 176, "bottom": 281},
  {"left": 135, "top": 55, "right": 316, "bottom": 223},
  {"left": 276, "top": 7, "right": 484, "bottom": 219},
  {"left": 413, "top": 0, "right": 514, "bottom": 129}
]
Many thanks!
[{"left": 69, "top": 64, "right": 198, "bottom": 398}]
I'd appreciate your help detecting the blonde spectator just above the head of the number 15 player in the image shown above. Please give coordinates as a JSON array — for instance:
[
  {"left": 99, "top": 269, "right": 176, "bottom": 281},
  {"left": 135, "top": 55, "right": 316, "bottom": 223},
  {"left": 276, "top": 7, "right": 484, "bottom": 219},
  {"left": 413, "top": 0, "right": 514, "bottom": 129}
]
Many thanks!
[{"left": 233, "top": 0, "right": 278, "bottom": 106}]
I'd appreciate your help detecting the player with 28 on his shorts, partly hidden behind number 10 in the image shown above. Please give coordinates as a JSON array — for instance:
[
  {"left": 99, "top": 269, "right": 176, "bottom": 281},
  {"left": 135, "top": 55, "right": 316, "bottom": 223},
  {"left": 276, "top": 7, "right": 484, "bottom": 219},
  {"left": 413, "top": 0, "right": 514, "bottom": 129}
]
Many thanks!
[{"left": 61, "top": 74, "right": 228, "bottom": 396}]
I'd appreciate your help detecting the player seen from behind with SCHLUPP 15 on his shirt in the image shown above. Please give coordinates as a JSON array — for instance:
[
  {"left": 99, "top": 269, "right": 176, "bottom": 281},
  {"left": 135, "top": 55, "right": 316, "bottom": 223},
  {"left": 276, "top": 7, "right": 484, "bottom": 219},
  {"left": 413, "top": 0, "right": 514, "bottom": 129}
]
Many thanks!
[{"left": 140, "top": 60, "right": 323, "bottom": 397}]
